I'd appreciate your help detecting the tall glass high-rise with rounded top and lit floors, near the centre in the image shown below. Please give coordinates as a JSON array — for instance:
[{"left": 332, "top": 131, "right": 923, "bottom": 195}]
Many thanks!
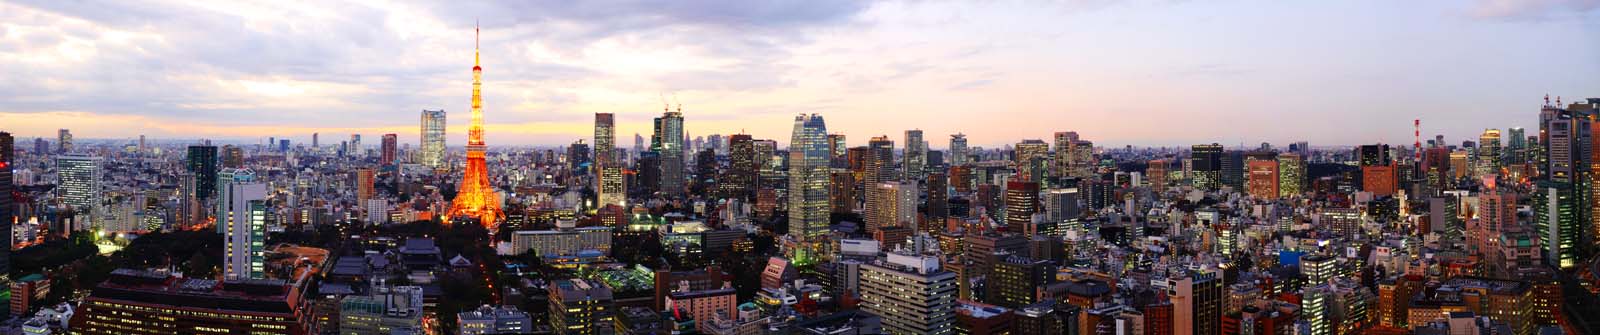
[{"left": 789, "top": 114, "right": 832, "bottom": 237}]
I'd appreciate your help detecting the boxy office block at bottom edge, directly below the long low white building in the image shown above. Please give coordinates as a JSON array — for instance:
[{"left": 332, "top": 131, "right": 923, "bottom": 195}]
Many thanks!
[{"left": 549, "top": 279, "right": 616, "bottom": 335}]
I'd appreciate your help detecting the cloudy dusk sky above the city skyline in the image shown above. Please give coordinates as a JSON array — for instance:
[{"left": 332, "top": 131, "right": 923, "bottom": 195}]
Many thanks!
[{"left": 0, "top": 0, "right": 1600, "bottom": 147}]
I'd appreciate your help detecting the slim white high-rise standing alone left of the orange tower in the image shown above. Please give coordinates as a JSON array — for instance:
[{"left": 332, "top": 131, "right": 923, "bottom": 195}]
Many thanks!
[{"left": 219, "top": 181, "right": 267, "bottom": 279}]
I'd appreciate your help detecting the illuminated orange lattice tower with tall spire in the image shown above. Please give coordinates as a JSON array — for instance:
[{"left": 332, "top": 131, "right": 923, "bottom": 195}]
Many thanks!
[{"left": 448, "top": 22, "right": 501, "bottom": 231}]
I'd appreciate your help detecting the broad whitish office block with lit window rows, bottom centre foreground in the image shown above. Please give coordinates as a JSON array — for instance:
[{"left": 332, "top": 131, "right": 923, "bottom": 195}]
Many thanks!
[{"left": 858, "top": 252, "right": 957, "bottom": 335}]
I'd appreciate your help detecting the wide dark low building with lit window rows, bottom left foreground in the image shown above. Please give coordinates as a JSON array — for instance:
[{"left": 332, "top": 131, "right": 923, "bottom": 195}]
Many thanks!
[{"left": 70, "top": 269, "right": 312, "bottom": 335}]
